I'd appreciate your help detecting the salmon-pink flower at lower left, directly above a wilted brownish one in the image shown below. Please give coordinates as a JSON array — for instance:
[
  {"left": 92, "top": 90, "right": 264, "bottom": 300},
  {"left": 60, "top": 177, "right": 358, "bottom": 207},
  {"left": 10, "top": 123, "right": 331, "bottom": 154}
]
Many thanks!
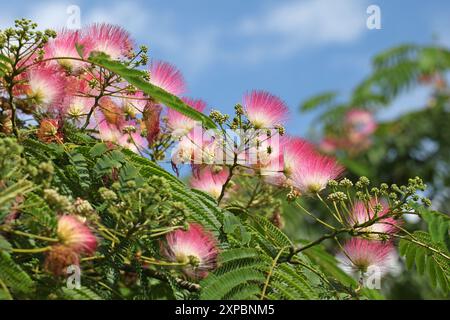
[{"left": 56, "top": 215, "right": 97, "bottom": 254}]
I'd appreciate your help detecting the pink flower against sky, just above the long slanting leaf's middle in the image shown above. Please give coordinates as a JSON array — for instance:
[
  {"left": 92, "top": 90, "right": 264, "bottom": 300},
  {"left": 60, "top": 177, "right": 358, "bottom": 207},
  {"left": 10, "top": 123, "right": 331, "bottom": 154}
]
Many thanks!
[{"left": 149, "top": 61, "right": 186, "bottom": 96}]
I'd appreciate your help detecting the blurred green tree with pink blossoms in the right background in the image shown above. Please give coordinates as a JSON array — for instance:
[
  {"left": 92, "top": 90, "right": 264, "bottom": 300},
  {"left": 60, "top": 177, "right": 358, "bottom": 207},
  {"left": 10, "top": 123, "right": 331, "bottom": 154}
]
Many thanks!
[{"left": 298, "top": 45, "right": 450, "bottom": 299}]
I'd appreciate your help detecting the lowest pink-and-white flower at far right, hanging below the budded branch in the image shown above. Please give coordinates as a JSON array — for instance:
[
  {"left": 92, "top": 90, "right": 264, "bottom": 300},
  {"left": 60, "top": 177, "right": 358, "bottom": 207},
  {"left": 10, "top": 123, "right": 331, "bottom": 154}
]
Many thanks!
[{"left": 336, "top": 238, "right": 396, "bottom": 277}]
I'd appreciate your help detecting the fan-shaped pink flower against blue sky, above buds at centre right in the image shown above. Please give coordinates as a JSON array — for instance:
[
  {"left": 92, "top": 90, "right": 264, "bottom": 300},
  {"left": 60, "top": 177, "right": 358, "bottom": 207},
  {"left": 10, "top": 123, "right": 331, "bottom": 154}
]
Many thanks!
[{"left": 243, "top": 91, "right": 288, "bottom": 129}]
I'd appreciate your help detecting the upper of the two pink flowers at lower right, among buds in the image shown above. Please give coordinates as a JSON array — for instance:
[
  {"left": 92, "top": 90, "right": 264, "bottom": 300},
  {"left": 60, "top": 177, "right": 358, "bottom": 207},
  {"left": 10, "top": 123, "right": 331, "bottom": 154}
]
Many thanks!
[{"left": 349, "top": 199, "right": 400, "bottom": 239}]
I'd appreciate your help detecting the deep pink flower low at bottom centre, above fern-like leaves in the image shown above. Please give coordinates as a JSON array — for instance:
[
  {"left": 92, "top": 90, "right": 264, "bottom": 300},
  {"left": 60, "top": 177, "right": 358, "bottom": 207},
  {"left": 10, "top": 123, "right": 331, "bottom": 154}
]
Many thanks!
[{"left": 162, "top": 223, "right": 219, "bottom": 279}]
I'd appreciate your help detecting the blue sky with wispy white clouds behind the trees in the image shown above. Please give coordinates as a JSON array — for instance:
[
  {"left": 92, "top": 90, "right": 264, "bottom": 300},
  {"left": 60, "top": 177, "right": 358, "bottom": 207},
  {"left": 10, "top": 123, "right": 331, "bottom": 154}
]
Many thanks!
[{"left": 0, "top": 0, "right": 450, "bottom": 135}]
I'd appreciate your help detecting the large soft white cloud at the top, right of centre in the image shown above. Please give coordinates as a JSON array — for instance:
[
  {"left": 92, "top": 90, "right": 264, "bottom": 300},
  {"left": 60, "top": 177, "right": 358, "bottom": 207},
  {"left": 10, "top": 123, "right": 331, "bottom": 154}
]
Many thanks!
[{"left": 238, "top": 0, "right": 367, "bottom": 60}]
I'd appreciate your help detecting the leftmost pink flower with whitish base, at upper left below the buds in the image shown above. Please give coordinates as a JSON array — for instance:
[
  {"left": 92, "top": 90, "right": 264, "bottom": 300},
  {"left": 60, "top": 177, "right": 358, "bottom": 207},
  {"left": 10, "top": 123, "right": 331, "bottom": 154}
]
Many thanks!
[{"left": 24, "top": 67, "right": 65, "bottom": 112}]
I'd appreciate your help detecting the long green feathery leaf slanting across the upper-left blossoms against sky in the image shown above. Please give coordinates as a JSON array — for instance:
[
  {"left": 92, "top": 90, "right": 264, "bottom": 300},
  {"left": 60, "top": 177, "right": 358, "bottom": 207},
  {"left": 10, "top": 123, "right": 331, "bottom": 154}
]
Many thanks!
[{"left": 89, "top": 53, "right": 216, "bottom": 129}]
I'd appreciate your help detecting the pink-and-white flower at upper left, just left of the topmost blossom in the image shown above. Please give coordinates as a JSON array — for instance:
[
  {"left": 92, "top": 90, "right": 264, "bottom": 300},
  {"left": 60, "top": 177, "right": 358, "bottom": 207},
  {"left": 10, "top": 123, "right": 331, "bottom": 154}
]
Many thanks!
[{"left": 44, "top": 29, "right": 92, "bottom": 72}]
